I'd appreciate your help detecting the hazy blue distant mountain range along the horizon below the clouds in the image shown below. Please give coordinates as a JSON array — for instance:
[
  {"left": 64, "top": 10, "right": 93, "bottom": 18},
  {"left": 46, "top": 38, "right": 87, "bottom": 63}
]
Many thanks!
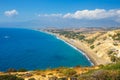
[{"left": 0, "top": 17, "right": 120, "bottom": 28}]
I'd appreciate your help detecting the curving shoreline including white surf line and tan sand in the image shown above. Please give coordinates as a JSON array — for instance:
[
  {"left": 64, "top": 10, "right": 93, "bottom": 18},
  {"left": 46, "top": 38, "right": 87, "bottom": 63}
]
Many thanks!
[{"left": 36, "top": 30, "right": 108, "bottom": 66}]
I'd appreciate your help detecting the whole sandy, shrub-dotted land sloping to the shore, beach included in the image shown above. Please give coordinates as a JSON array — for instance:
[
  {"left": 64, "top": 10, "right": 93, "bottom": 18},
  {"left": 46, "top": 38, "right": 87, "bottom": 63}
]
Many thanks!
[{"left": 46, "top": 29, "right": 120, "bottom": 65}]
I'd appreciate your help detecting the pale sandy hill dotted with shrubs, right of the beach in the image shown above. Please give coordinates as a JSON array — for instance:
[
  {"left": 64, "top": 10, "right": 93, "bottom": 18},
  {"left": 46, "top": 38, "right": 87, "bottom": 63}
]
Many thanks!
[{"left": 83, "top": 30, "right": 120, "bottom": 62}]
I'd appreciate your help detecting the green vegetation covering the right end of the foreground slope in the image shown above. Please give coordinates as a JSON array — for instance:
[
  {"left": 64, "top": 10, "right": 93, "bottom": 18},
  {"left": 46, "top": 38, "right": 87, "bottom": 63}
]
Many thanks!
[{"left": 78, "top": 62, "right": 120, "bottom": 80}]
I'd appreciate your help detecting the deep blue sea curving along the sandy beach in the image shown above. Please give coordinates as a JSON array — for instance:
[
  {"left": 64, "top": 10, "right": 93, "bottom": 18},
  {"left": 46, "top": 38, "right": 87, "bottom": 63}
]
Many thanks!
[{"left": 0, "top": 28, "right": 91, "bottom": 71}]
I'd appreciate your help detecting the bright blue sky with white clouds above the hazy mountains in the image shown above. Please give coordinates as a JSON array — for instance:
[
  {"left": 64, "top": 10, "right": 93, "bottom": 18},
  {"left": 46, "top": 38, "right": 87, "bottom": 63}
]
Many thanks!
[{"left": 0, "top": 0, "right": 120, "bottom": 27}]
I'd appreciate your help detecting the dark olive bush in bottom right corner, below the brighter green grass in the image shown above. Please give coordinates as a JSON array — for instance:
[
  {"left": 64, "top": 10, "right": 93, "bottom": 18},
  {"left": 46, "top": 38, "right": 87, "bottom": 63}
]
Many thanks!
[{"left": 78, "top": 69, "right": 120, "bottom": 80}]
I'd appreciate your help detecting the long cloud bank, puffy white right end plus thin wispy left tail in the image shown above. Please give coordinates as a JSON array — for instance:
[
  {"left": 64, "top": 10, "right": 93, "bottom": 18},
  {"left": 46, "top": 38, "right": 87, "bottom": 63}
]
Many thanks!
[{"left": 38, "top": 9, "right": 120, "bottom": 23}]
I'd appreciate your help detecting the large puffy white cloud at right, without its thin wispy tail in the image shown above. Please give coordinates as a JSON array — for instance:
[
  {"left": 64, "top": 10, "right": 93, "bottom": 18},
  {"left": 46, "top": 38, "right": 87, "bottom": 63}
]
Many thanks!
[{"left": 63, "top": 9, "right": 120, "bottom": 20}]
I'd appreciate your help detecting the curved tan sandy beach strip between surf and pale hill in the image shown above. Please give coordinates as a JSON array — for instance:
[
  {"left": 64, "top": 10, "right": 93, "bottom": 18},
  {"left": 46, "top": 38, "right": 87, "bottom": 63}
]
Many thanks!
[{"left": 55, "top": 34, "right": 108, "bottom": 65}]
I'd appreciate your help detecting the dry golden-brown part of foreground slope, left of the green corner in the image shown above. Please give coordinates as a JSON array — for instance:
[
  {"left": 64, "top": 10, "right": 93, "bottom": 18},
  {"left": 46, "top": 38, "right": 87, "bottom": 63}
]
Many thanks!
[{"left": 0, "top": 66, "right": 99, "bottom": 80}]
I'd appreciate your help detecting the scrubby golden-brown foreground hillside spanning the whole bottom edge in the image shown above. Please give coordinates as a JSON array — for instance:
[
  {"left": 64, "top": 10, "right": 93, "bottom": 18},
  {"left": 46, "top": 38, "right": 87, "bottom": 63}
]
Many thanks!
[{"left": 0, "top": 62, "right": 120, "bottom": 80}]
